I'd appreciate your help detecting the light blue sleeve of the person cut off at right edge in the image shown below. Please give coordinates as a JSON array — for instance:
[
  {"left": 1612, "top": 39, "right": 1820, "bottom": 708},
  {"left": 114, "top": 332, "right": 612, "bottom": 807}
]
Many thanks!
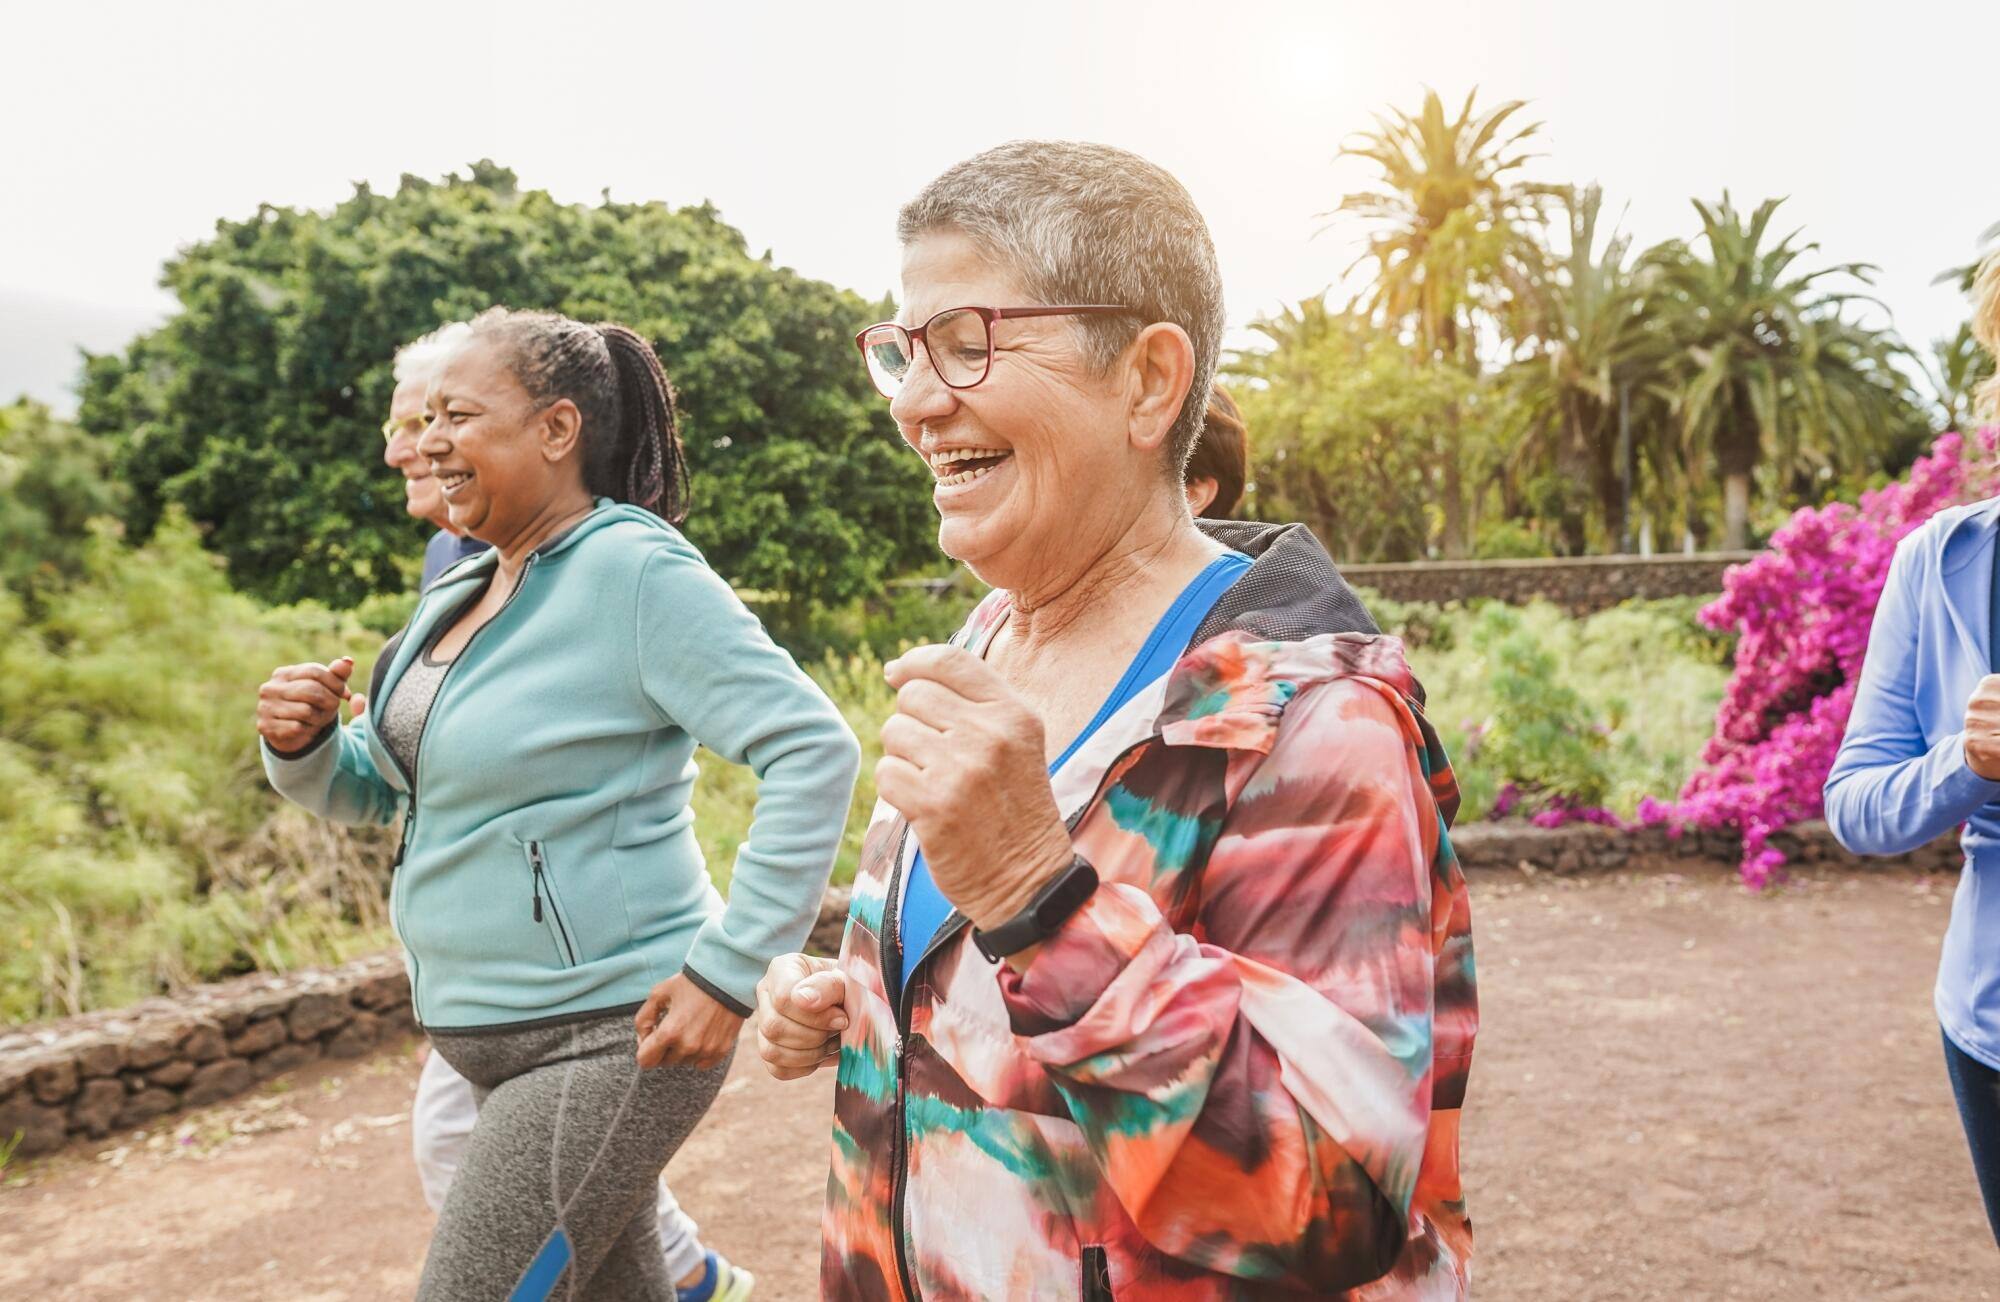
[{"left": 1824, "top": 534, "right": 2000, "bottom": 854}]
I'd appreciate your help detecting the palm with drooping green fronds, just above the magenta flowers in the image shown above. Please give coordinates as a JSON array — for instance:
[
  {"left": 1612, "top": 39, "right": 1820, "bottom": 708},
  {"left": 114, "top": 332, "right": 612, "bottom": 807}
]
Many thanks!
[{"left": 1642, "top": 194, "right": 1910, "bottom": 550}]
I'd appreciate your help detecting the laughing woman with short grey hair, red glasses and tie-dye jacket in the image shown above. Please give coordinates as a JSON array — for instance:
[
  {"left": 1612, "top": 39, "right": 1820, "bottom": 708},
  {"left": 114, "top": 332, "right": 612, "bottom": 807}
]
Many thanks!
[{"left": 758, "top": 142, "right": 1476, "bottom": 1298}]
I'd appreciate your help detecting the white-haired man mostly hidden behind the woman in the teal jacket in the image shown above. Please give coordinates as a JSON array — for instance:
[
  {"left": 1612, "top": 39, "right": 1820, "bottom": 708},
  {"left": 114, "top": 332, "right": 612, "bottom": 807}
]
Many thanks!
[{"left": 378, "top": 322, "right": 756, "bottom": 1302}]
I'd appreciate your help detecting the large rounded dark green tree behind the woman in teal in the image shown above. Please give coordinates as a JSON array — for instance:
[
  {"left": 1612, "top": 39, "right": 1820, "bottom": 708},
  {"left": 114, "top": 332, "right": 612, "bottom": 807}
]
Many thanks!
[{"left": 80, "top": 162, "right": 932, "bottom": 606}]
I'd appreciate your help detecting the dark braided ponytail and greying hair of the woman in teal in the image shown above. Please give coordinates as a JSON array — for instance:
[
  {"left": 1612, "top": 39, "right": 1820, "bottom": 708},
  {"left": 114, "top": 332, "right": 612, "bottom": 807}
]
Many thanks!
[{"left": 472, "top": 308, "right": 690, "bottom": 524}]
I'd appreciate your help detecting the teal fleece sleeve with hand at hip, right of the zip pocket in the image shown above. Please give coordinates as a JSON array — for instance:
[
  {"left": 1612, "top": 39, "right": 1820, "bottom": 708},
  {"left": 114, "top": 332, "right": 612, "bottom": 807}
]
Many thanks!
[{"left": 638, "top": 540, "right": 860, "bottom": 1016}]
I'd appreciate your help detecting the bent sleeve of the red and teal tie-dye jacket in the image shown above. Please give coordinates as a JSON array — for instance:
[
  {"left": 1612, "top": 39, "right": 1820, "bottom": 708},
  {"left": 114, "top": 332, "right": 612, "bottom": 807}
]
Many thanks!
[{"left": 1000, "top": 678, "right": 1442, "bottom": 1296}]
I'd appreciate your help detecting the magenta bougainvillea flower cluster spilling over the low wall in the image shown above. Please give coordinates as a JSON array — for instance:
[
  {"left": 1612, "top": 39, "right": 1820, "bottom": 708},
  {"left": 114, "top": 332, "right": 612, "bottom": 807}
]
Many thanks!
[{"left": 1640, "top": 428, "right": 2000, "bottom": 886}]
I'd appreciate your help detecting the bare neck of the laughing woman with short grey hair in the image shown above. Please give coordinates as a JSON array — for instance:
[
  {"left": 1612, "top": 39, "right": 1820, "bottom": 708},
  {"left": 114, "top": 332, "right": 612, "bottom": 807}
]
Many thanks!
[{"left": 1006, "top": 498, "right": 1222, "bottom": 660}]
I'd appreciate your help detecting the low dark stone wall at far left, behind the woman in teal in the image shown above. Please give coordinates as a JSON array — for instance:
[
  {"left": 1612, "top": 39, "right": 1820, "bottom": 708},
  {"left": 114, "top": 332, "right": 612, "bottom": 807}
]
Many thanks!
[{"left": 0, "top": 954, "right": 416, "bottom": 1154}]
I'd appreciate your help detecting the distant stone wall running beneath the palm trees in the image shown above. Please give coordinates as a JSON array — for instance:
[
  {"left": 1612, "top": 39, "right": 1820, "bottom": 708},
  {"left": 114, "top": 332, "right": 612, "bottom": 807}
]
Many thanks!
[{"left": 1340, "top": 552, "right": 1756, "bottom": 614}]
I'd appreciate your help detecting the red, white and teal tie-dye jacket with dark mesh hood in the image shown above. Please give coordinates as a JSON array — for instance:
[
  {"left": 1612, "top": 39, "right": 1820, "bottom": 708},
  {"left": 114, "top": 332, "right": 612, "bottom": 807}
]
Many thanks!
[{"left": 820, "top": 526, "right": 1478, "bottom": 1300}]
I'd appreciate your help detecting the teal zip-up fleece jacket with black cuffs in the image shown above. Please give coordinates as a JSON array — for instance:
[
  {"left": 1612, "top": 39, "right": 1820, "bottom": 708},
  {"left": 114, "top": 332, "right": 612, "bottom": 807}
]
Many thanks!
[{"left": 264, "top": 498, "right": 860, "bottom": 1030}]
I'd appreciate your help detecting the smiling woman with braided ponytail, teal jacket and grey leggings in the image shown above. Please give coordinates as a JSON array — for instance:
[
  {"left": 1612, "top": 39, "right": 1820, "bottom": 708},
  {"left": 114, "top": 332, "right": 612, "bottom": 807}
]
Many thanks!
[{"left": 258, "top": 310, "right": 860, "bottom": 1300}]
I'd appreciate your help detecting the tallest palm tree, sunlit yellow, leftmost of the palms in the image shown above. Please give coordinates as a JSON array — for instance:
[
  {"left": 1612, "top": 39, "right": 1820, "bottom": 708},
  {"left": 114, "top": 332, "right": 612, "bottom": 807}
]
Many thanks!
[{"left": 1328, "top": 88, "right": 1550, "bottom": 556}]
